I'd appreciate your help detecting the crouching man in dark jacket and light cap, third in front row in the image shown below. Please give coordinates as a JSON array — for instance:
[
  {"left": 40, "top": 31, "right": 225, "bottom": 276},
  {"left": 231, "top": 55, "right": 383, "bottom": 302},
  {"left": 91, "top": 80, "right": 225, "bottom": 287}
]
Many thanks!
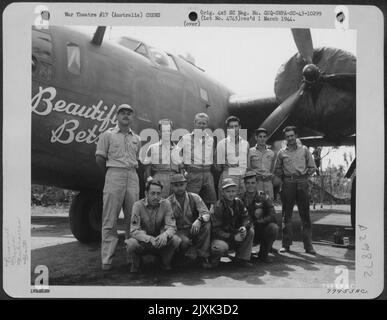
[{"left": 211, "top": 178, "right": 254, "bottom": 267}]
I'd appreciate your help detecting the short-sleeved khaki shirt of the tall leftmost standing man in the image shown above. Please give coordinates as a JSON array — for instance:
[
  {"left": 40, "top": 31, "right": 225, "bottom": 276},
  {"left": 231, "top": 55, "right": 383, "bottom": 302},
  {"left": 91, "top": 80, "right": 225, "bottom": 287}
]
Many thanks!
[{"left": 95, "top": 125, "right": 141, "bottom": 169}]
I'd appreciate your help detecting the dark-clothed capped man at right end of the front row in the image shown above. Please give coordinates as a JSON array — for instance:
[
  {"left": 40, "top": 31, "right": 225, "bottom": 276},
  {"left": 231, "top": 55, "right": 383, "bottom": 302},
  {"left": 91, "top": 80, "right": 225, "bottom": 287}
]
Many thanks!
[{"left": 241, "top": 171, "right": 279, "bottom": 263}]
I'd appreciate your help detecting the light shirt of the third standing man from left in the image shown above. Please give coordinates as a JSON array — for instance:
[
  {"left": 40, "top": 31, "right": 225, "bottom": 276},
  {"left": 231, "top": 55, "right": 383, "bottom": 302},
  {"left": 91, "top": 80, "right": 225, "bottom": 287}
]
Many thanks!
[{"left": 172, "top": 132, "right": 214, "bottom": 167}]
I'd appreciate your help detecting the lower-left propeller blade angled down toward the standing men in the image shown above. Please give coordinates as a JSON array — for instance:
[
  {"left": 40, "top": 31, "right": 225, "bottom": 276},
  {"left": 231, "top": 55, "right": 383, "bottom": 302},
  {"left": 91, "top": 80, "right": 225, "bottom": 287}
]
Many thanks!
[{"left": 260, "top": 82, "right": 305, "bottom": 138}]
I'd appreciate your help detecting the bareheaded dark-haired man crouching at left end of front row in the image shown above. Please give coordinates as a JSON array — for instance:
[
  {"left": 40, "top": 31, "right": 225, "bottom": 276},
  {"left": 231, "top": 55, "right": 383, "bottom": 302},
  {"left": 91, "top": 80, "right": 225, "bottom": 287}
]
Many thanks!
[{"left": 125, "top": 180, "right": 181, "bottom": 273}]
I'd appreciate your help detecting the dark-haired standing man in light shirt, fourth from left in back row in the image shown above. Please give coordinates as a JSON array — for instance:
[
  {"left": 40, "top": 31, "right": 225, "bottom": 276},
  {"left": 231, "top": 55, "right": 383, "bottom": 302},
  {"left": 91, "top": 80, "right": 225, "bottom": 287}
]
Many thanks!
[{"left": 216, "top": 116, "right": 249, "bottom": 199}]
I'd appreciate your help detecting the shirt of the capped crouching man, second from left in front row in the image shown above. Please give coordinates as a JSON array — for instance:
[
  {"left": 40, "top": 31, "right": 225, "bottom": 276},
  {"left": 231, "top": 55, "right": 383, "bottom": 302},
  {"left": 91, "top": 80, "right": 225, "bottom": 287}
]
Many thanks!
[{"left": 167, "top": 192, "right": 210, "bottom": 231}]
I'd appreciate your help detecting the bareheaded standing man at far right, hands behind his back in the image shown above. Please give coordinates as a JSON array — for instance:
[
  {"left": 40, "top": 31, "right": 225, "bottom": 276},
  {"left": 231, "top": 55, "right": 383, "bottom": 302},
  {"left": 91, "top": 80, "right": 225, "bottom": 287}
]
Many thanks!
[{"left": 275, "top": 126, "right": 316, "bottom": 254}]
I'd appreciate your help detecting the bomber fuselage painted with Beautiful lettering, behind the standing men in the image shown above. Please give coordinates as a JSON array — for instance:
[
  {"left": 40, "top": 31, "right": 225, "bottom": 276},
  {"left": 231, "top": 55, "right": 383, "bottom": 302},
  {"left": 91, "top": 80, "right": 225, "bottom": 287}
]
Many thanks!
[{"left": 31, "top": 27, "right": 232, "bottom": 190}]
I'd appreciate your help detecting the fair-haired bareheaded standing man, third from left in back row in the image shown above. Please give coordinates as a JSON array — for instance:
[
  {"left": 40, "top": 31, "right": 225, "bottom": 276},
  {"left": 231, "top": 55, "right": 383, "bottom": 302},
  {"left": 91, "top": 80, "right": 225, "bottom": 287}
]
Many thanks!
[{"left": 173, "top": 113, "right": 216, "bottom": 207}]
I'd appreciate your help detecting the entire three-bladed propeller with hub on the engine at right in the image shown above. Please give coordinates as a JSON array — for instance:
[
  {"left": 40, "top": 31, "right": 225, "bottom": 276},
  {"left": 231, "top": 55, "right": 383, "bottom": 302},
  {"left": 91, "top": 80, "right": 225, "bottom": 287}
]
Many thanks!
[{"left": 260, "top": 29, "right": 356, "bottom": 138}]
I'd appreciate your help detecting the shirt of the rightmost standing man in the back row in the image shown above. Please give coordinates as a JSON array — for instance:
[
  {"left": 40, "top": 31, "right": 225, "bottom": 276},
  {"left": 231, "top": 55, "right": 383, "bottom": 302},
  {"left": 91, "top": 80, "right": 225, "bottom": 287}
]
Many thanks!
[{"left": 275, "top": 145, "right": 316, "bottom": 177}]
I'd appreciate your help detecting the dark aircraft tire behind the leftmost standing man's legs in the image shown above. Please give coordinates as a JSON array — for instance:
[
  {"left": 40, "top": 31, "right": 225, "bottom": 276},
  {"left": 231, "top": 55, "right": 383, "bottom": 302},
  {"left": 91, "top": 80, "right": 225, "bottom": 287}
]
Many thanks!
[{"left": 69, "top": 192, "right": 102, "bottom": 243}]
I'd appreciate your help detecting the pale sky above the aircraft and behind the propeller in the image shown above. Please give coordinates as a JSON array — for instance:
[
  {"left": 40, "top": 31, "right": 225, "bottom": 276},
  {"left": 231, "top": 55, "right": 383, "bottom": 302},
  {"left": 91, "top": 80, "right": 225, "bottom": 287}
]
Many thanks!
[{"left": 76, "top": 26, "right": 356, "bottom": 168}]
